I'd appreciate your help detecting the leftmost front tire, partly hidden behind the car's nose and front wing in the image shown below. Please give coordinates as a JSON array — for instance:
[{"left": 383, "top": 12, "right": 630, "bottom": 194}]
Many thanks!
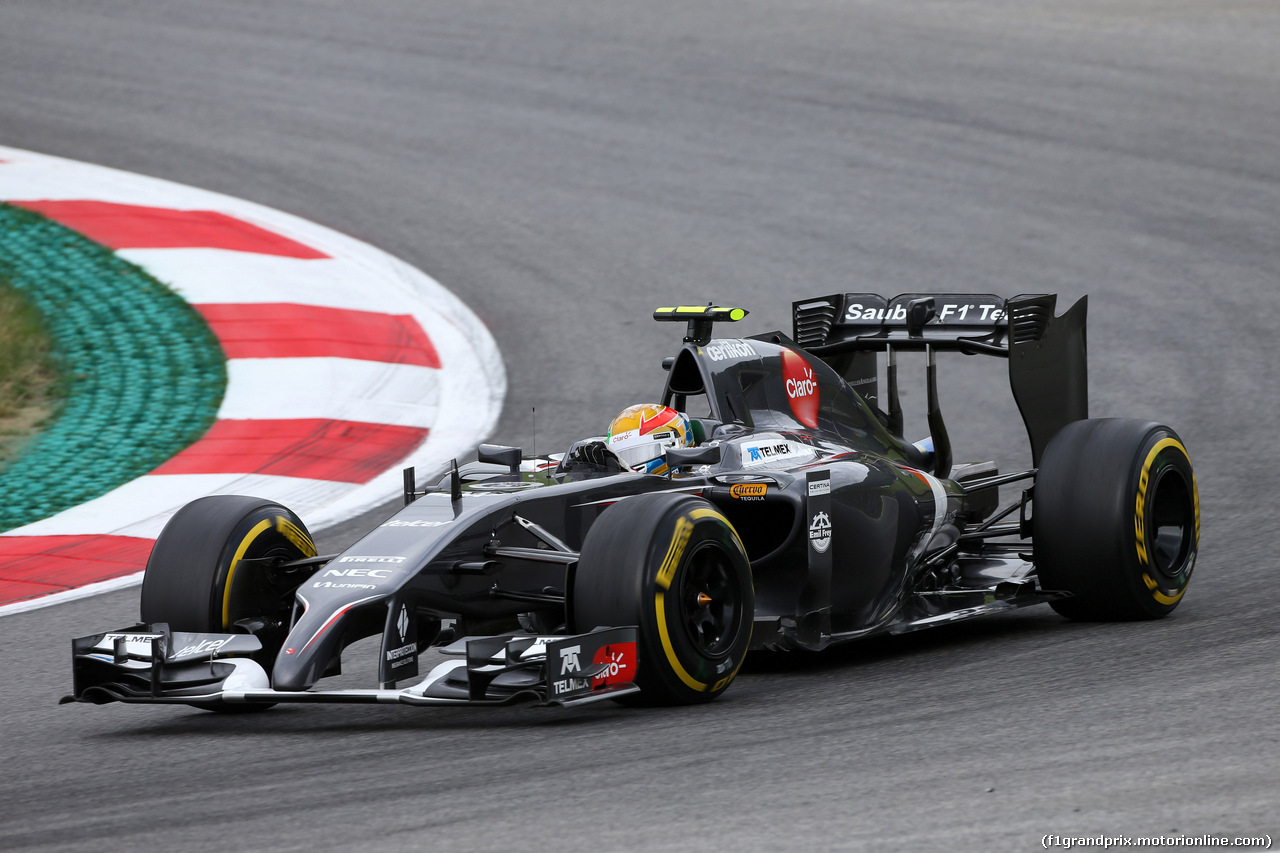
[{"left": 142, "top": 494, "right": 316, "bottom": 711}]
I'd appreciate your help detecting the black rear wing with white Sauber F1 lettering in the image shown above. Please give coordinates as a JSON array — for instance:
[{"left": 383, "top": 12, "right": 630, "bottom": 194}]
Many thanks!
[{"left": 792, "top": 293, "right": 1089, "bottom": 466}]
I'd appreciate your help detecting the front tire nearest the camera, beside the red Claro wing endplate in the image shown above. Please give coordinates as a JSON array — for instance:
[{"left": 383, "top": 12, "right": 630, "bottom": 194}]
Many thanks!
[{"left": 571, "top": 492, "right": 755, "bottom": 704}]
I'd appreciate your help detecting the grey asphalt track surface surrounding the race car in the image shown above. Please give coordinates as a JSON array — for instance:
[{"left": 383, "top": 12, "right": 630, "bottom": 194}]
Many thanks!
[{"left": 0, "top": 0, "right": 1280, "bottom": 850}]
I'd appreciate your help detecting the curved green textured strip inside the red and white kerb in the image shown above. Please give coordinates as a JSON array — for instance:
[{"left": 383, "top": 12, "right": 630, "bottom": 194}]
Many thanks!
[{"left": 0, "top": 204, "right": 227, "bottom": 530}]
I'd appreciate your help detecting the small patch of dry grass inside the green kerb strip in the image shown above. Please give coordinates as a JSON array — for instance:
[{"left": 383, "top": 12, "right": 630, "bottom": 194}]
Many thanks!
[{"left": 0, "top": 278, "right": 61, "bottom": 469}]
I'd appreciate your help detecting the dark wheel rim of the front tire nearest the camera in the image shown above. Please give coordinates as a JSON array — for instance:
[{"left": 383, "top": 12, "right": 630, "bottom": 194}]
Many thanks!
[{"left": 680, "top": 542, "right": 742, "bottom": 658}]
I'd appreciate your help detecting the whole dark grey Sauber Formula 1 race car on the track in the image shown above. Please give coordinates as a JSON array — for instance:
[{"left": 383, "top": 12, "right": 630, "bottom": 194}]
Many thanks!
[{"left": 64, "top": 293, "right": 1199, "bottom": 711}]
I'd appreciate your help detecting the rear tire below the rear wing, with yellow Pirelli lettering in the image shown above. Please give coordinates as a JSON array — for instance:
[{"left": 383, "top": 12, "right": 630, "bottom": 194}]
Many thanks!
[{"left": 1032, "top": 419, "right": 1199, "bottom": 621}]
